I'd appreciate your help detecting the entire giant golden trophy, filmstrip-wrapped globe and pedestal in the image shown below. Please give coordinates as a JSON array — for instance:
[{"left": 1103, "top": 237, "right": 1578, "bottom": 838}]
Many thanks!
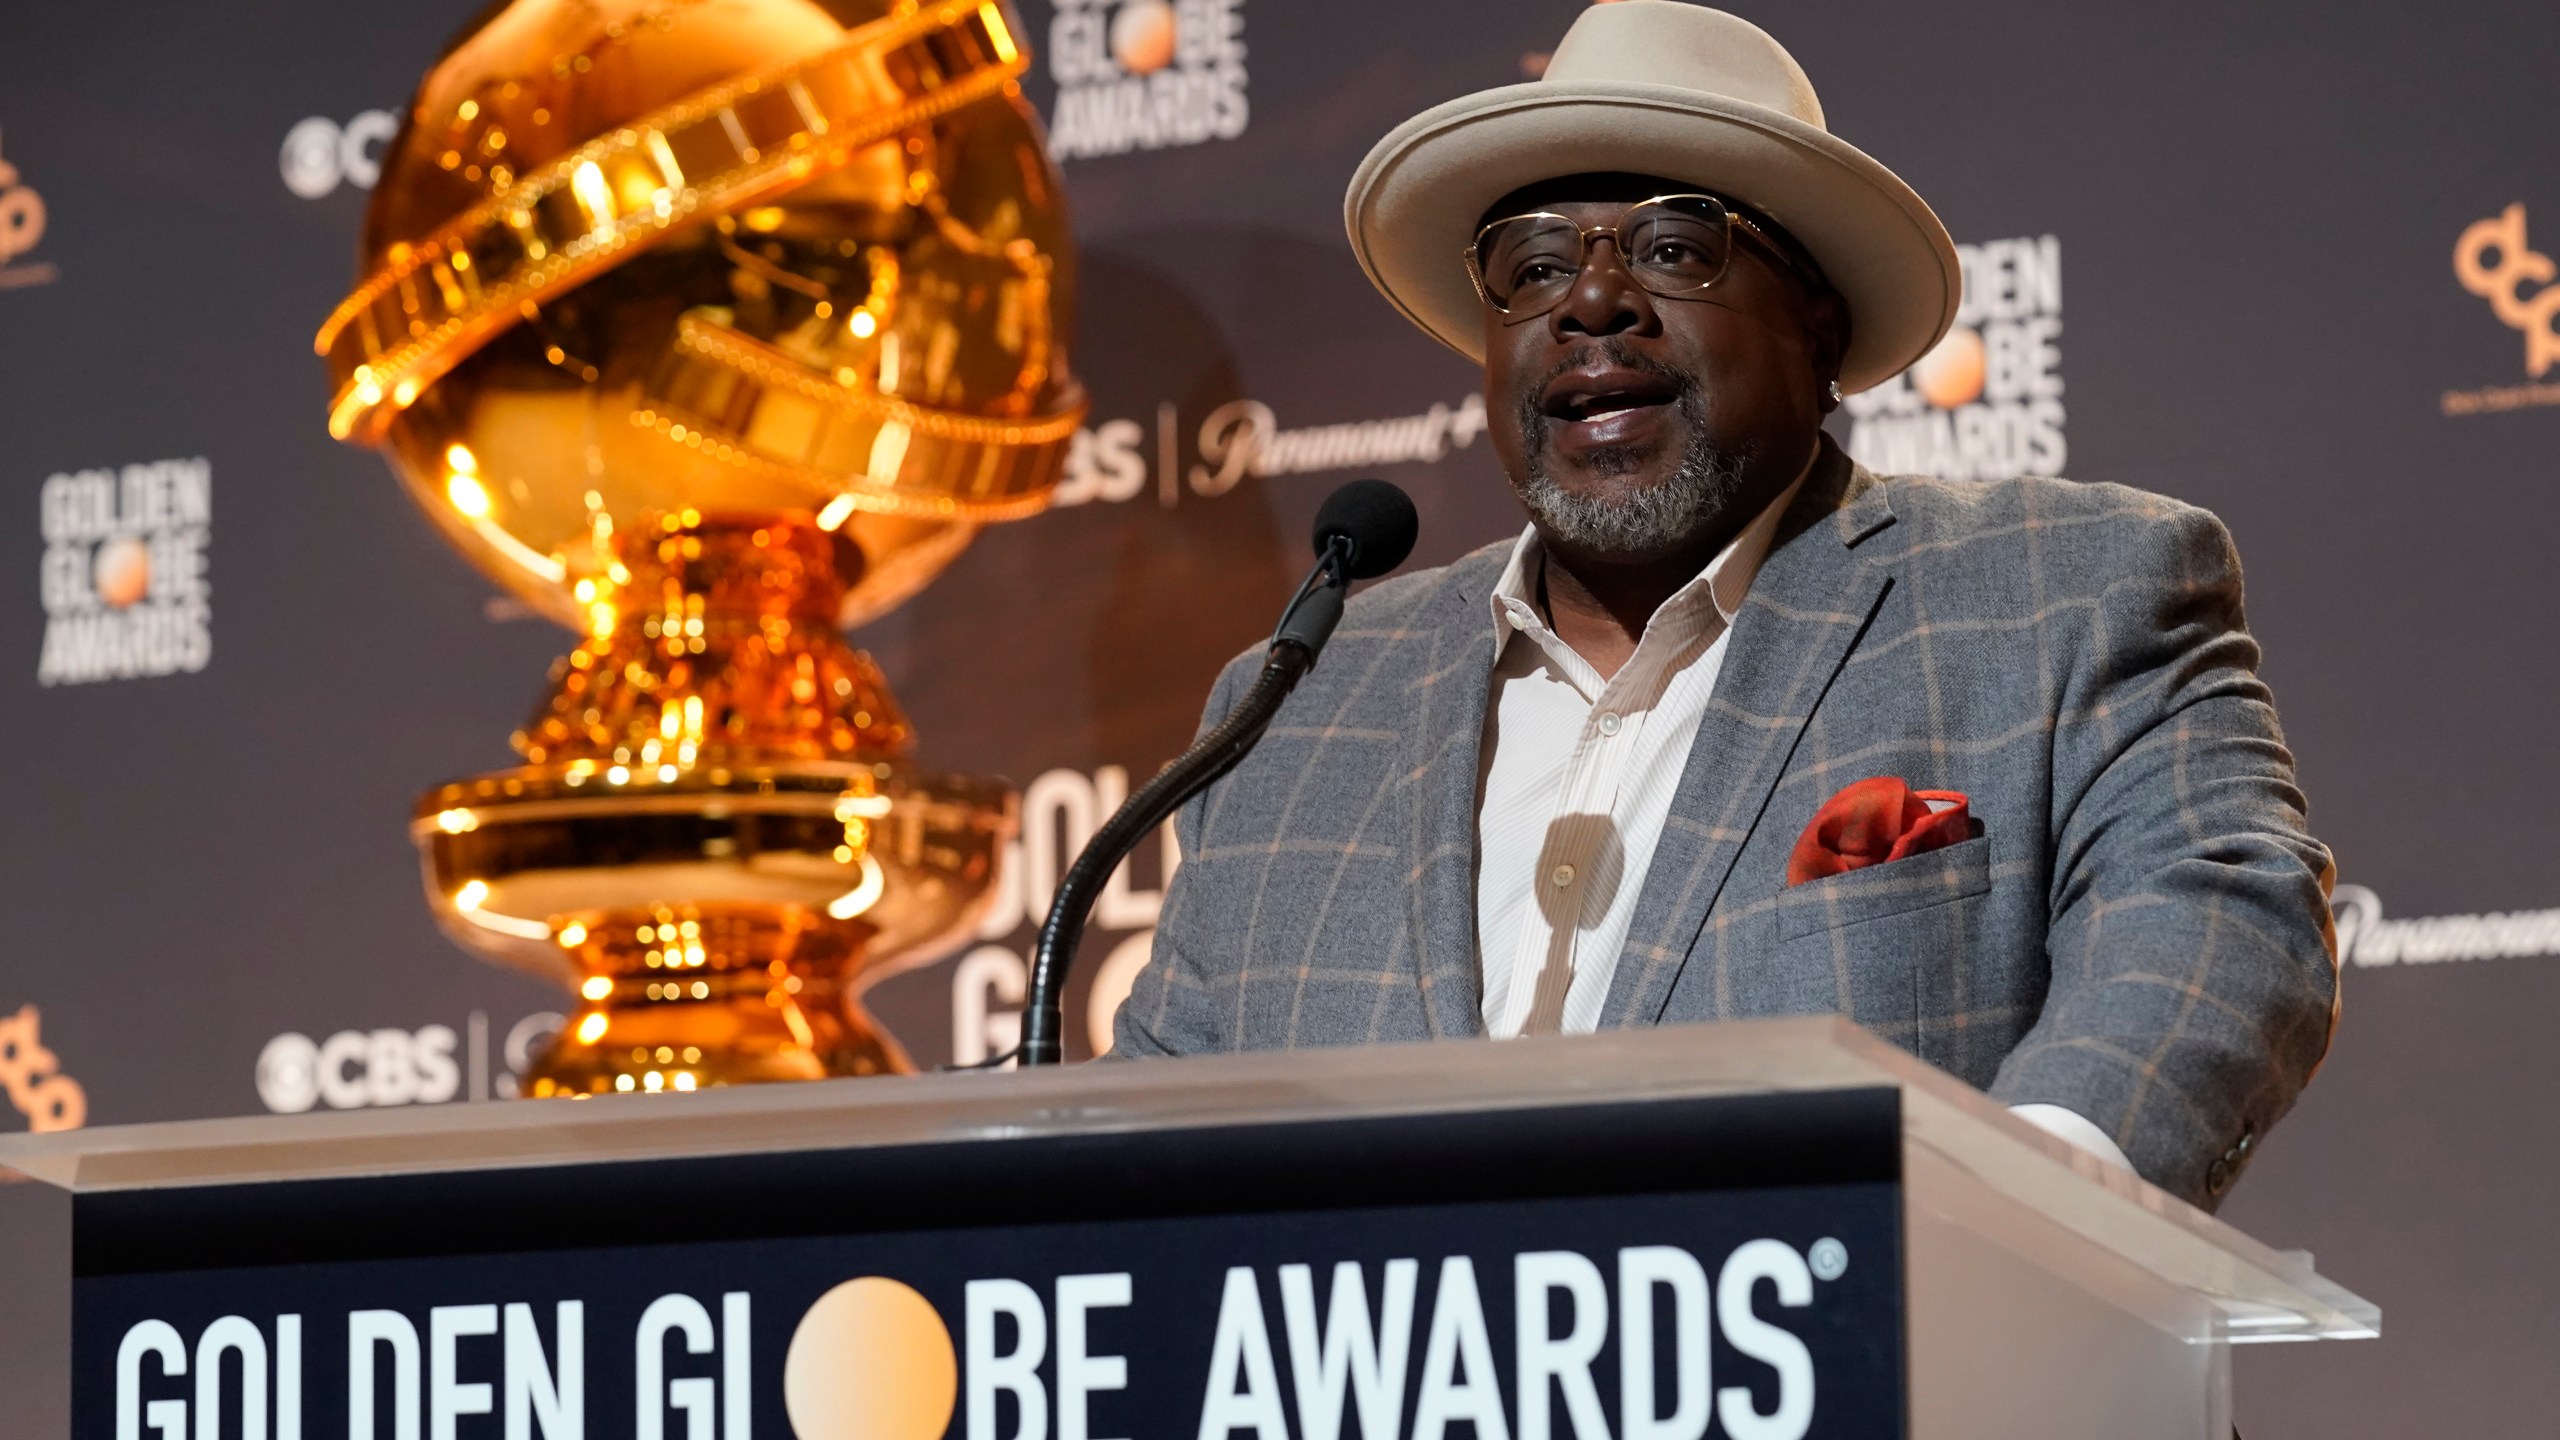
[{"left": 317, "top": 0, "right": 1083, "bottom": 1094}]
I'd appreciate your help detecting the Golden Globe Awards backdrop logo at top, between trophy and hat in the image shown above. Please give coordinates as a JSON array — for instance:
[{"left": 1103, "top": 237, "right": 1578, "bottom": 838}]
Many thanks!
[{"left": 1050, "top": 0, "right": 1249, "bottom": 161}]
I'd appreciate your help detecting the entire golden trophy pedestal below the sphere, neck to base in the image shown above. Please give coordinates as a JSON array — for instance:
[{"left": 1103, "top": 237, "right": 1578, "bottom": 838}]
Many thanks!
[{"left": 412, "top": 512, "right": 1014, "bottom": 1097}]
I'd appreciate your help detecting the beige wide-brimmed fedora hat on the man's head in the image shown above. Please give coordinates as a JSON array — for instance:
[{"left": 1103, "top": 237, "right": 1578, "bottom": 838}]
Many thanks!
[{"left": 1341, "top": 0, "right": 1964, "bottom": 392}]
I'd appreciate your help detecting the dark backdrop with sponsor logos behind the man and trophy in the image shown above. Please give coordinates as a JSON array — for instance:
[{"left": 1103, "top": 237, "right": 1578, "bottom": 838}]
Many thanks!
[{"left": 0, "top": 0, "right": 2560, "bottom": 1437}]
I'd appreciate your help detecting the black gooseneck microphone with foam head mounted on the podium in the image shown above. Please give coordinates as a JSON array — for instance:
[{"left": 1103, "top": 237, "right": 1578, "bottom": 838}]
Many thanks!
[{"left": 1013, "top": 479, "right": 1421, "bottom": 1066}]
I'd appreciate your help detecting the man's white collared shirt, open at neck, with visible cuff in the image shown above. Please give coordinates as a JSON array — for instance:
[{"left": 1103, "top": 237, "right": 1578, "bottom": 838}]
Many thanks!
[{"left": 1475, "top": 466, "right": 2132, "bottom": 1168}]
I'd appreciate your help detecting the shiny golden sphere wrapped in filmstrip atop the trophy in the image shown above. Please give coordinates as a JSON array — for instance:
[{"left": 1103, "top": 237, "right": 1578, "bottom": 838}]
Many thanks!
[{"left": 320, "top": 0, "right": 1083, "bottom": 625}]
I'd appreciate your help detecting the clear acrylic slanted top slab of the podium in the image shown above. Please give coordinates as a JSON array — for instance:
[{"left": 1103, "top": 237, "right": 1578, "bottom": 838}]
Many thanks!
[{"left": 0, "top": 1017, "right": 2381, "bottom": 1343}]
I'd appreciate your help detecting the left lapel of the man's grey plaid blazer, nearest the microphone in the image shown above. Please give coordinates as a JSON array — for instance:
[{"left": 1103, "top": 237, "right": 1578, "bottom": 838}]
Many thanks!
[{"left": 1405, "top": 546, "right": 1508, "bottom": 1038}]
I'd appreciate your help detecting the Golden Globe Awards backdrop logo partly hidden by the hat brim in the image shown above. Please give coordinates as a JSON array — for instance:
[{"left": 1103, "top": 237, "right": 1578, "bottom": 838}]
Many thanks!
[{"left": 1846, "top": 236, "right": 2068, "bottom": 479}]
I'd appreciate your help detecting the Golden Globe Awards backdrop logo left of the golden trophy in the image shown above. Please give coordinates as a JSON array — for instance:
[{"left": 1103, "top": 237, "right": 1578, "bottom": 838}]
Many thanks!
[{"left": 36, "top": 456, "right": 212, "bottom": 684}]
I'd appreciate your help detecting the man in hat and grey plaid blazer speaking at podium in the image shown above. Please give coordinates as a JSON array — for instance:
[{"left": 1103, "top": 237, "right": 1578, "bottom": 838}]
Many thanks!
[{"left": 1114, "top": 0, "right": 2337, "bottom": 1204}]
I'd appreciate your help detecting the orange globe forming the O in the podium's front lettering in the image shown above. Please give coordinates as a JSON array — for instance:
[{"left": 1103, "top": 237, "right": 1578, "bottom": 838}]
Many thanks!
[{"left": 783, "top": 1276, "right": 960, "bottom": 1440}]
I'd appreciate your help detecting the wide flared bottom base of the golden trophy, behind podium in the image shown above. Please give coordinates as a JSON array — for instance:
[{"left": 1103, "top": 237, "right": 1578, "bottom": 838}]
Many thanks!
[{"left": 412, "top": 761, "right": 1014, "bottom": 1097}]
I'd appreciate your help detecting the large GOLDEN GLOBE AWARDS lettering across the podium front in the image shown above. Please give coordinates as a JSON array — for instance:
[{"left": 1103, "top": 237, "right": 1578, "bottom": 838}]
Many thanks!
[{"left": 115, "top": 1240, "right": 1848, "bottom": 1440}]
